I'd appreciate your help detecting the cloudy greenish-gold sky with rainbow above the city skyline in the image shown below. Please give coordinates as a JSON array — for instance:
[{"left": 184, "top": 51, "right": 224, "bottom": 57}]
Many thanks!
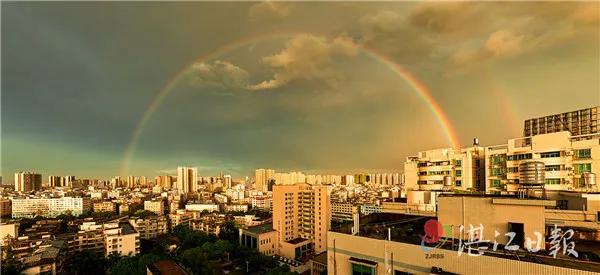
[{"left": 0, "top": 1, "right": 600, "bottom": 182}]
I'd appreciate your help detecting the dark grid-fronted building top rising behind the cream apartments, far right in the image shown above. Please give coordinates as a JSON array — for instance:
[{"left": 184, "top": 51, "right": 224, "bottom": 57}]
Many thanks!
[{"left": 523, "top": 106, "right": 600, "bottom": 139}]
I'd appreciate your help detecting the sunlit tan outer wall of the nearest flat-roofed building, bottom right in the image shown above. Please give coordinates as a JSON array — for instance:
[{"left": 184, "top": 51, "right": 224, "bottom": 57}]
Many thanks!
[{"left": 327, "top": 232, "right": 597, "bottom": 275}]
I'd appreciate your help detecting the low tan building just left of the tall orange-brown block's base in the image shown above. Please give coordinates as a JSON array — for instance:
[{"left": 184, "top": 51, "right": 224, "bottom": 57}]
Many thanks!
[{"left": 239, "top": 223, "right": 277, "bottom": 256}]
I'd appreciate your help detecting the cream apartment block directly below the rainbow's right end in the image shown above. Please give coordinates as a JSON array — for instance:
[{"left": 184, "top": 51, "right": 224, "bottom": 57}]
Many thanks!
[{"left": 404, "top": 146, "right": 485, "bottom": 191}]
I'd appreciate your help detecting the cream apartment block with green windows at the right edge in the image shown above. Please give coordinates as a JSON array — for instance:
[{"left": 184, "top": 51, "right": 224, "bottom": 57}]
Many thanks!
[{"left": 485, "top": 131, "right": 600, "bottom": 192}]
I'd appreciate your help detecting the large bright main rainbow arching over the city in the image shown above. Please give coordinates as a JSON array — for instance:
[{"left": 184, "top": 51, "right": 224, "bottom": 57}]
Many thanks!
[{"left": 119, "top": 31, "right": 460, "bottom": 176}]
